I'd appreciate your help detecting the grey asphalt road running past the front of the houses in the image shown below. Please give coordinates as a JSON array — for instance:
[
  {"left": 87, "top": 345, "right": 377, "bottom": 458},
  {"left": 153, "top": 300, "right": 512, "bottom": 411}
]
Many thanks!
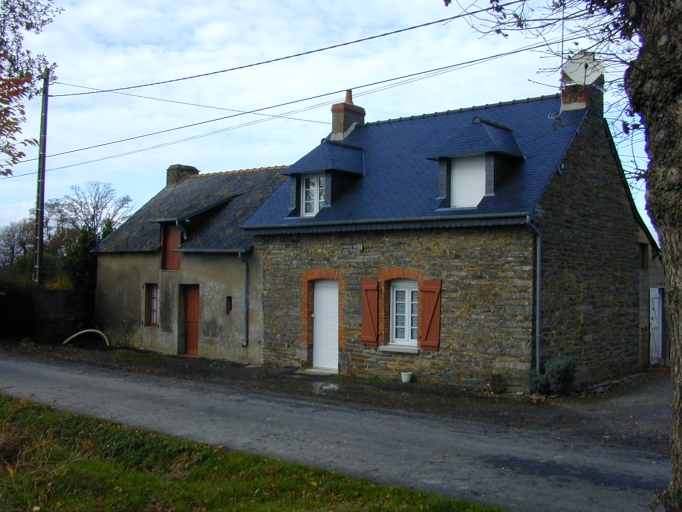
[{"left": 0, "top": 354, "right": 670, "bottom": 512}]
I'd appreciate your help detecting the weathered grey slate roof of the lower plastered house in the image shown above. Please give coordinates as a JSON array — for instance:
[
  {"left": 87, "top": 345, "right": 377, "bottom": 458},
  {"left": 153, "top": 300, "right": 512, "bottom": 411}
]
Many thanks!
[{"left": 94, "top": 166, "right": 286, "bottom": 253}]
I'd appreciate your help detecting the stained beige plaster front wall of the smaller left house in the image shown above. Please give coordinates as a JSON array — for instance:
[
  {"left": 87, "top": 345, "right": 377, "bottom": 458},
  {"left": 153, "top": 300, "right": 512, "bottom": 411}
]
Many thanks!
[{"left": 97, "top": 253, "right": 263, "bottom": 364}]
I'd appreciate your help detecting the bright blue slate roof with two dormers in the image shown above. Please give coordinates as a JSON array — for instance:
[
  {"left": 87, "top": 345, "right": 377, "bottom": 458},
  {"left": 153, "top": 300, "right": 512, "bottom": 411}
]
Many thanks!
[{"left": 242, "top": 95, "right": 587, "bottom": 233}]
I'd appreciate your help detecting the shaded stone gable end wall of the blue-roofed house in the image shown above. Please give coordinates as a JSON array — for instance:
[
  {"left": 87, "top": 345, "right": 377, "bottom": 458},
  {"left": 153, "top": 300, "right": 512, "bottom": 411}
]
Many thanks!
[{"left": 536, "top": 115, "right": 639, "bottom": 381}]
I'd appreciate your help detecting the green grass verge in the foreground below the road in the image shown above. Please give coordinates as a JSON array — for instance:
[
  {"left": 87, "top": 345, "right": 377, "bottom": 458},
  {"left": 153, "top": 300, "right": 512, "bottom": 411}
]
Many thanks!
[{"left": 0, "top": 395, "right": 499, "bottom": 512}]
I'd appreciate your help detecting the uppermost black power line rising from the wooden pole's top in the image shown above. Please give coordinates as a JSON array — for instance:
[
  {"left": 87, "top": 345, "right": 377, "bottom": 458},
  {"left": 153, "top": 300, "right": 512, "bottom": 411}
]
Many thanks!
[{"left": 51, "top": 0, "right": 525, "bottom": 98}]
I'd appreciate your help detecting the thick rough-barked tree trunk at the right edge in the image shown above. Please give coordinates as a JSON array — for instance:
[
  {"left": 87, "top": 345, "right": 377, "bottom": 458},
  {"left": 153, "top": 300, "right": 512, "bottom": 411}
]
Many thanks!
[{"left": 625, "top": 0, "right": 682, "bottom": 504}]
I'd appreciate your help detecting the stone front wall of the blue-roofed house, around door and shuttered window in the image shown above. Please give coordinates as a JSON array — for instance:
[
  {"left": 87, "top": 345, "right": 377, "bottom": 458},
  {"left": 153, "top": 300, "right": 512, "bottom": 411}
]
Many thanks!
[{"left": 256, "top": 226, "right": 533, "bottom": 389}]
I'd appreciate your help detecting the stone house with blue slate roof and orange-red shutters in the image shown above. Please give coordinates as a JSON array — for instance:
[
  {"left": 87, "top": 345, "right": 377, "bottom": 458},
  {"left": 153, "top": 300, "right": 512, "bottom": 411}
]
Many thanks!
[{"left": 242, "top": 84, "right": 656, "bottom": 389}]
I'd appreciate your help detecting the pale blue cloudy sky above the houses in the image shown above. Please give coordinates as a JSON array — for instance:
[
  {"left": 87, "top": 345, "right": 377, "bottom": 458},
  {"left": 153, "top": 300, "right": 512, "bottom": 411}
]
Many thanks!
[{"left": 0, "top": 0, "right": 648, "bottom": 238}]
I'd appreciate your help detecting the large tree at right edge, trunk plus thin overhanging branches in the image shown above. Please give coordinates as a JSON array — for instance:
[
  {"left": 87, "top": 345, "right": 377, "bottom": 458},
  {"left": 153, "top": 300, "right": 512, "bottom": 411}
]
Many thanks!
[{"left": 444, "top": 0, "right": 682, "bottom": 504}]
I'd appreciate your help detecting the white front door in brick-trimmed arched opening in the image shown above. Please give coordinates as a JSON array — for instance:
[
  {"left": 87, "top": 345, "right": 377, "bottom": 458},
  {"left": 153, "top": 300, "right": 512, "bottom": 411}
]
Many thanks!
[{"left": 313, "top": 279, "right": 339, "bottom": 372}]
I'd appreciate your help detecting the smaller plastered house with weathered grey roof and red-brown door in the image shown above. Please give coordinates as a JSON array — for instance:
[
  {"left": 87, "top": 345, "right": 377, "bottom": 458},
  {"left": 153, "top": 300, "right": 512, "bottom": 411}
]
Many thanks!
[{"left": 95, "top": 165, "right": 285, "bottom": 364}]
